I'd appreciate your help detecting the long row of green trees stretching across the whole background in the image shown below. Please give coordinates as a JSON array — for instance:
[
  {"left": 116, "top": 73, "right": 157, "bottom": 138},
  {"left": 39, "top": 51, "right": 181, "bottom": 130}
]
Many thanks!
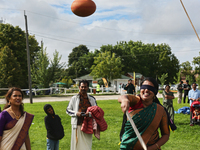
[{"left": 0, "top": 24, "right": 200, "bottom": 88}]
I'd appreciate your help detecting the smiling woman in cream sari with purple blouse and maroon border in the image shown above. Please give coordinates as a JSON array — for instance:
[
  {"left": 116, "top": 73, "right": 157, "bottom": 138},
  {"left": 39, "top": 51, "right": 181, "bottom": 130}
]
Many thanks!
[{"left": 0, "top": 87, "right": 34, "bottom": 150}]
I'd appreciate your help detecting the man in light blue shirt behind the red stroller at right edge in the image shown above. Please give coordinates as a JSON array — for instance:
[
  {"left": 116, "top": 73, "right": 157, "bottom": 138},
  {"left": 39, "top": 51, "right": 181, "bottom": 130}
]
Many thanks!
[{"left": 188, "top": 82, "right": 200, "bottom": 126}]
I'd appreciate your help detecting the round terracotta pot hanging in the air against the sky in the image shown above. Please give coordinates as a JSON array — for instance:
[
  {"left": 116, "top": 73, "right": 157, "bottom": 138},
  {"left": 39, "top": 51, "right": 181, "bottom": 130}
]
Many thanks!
[{"left": 71, "top": 0, "right": 96, "bottom": 17}]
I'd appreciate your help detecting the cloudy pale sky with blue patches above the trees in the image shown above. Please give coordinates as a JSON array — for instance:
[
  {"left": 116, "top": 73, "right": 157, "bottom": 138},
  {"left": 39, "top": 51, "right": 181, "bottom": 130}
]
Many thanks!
[{"left": 0, "top": 0, "right": 200, "bottom": 68}]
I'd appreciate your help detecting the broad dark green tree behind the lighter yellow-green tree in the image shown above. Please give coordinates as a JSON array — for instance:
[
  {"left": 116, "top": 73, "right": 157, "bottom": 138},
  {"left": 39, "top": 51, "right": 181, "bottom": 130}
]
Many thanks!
[{"left": 97, "top": 41, "right": 179, "bottom": 82}]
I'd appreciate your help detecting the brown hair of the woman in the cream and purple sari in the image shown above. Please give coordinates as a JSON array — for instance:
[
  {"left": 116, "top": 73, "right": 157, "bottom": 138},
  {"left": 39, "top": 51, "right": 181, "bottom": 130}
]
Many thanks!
[{"left": 3, "top": 87, "right": 24, "bottom": 115}]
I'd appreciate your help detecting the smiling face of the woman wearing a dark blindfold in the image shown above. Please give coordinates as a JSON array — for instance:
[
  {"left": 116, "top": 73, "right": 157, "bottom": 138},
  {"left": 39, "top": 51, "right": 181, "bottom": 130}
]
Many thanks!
[{"left": 140, "top": 80, "right": 155, "bottom": 102}]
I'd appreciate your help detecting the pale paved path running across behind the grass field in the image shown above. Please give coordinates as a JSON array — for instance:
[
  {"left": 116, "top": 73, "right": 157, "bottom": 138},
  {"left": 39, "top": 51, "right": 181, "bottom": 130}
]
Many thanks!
[{"left": 0, "top": 94, "right": 177, "bottom": 104}]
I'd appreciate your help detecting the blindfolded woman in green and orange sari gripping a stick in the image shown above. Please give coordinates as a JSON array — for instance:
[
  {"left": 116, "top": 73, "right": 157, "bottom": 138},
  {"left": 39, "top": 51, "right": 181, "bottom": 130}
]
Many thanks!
[{"left": 118, "top": 77, "right": 170, "bottom": 150}]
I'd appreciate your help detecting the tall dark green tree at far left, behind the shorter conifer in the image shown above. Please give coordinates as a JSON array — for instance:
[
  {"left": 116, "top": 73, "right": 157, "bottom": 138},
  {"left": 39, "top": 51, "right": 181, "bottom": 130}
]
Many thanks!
[{"left": 0, "top": 24, "right": 40, "bottom": 88}]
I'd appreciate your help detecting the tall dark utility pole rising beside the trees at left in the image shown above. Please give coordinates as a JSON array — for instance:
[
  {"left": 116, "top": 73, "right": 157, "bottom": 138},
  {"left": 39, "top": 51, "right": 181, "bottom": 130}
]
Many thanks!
[{"left": 24, "top": 10, "right": 33, "bottom": 104}]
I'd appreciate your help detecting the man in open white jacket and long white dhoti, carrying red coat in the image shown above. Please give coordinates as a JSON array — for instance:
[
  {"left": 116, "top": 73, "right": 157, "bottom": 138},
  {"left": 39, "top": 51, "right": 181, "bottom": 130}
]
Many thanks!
[{"left": 66, "top": 80, "right": 97, "bottom": 150}]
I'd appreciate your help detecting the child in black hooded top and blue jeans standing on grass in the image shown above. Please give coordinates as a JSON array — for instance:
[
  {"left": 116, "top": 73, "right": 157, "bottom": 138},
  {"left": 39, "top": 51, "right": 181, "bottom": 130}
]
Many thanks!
[{"left": 44, "top": 104, "right": 64, "bottom": 150}]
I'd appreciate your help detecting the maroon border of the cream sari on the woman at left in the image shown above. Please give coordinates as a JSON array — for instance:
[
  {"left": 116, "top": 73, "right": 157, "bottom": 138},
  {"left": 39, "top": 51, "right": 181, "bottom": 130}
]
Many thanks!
[{"left": 12, "top": 112, "right": 34, "bottom": 150}]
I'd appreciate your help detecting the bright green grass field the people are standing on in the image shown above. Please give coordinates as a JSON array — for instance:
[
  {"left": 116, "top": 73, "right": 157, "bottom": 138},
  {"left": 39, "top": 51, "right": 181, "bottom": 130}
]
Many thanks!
[{"left": 1, "top": 99, "right": 197, "bottom": 150}]
